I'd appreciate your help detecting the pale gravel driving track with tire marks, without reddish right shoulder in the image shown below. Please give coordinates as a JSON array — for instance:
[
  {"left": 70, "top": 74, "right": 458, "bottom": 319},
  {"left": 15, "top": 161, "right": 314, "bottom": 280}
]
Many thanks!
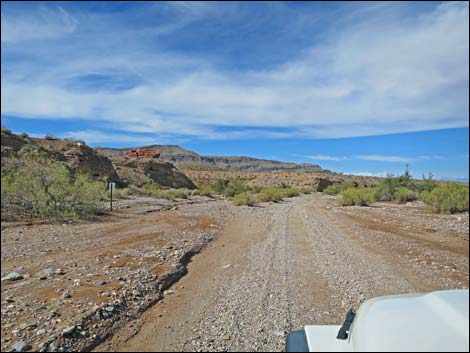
[{"left": 100, "top": 195, "right": 468, "bottom": 351}]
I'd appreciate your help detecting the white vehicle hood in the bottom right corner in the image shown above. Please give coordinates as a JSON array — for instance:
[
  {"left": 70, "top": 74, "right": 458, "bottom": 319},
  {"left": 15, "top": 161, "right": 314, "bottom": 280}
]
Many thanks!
[{"left": 305, "top": 290, "right": 469, "bottom": 352}]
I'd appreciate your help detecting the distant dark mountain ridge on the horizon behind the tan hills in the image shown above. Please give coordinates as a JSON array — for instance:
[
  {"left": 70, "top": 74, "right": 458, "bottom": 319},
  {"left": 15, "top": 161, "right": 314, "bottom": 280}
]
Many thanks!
[{"left": 95, "top": 145, "right": 329, "bottom": 172}]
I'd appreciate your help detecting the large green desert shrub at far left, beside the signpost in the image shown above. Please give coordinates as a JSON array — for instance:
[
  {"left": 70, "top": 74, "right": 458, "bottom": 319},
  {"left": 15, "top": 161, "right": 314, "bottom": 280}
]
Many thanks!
[{"left": 1, "top": 155, "right": 106, "bottom": 218}]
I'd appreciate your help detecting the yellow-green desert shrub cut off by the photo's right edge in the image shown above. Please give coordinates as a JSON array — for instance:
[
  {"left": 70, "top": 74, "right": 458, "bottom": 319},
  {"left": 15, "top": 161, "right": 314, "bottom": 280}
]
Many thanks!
[{"left": 421, "top": 184, "right": 468, "bottom": 213}]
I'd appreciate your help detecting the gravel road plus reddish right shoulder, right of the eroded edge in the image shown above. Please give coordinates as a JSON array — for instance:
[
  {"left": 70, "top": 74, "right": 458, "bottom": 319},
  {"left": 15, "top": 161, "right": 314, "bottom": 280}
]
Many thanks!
[{"left": 97, "top": 194, "right": 468, "bottom": 351}]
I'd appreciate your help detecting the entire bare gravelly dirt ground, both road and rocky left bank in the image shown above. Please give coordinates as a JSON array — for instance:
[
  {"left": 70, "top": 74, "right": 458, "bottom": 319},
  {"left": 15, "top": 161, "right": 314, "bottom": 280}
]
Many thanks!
[{"left": 2, "top": 194, "right": 469, "bottom": 351}]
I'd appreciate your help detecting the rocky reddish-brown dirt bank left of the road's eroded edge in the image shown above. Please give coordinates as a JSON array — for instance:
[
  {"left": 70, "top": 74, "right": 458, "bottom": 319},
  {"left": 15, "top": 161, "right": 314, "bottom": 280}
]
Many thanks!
[{"left": 1, "top": 200, "right": 230, "bottom": 351}]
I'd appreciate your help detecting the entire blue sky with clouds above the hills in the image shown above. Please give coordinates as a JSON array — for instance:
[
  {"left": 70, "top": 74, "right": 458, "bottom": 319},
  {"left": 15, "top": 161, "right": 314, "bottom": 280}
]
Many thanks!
[{"left": 1, "top": 2, "right": 469, "bottom": 180}]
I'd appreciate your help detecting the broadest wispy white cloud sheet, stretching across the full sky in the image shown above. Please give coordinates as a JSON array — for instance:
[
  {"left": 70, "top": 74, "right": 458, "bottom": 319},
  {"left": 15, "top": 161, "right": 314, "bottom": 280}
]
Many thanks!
[{"left": 1, "top": 2, "right": 469, "bottom": 139}]
